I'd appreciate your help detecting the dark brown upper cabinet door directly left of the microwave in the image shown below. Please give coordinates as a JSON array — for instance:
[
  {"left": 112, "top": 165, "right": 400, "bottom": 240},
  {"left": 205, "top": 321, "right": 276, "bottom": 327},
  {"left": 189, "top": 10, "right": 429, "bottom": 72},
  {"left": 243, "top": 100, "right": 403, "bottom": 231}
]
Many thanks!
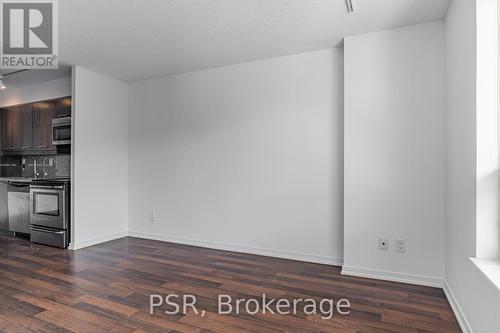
[{"left": 33, "top": 101, "right": 55, "bottom": 149}]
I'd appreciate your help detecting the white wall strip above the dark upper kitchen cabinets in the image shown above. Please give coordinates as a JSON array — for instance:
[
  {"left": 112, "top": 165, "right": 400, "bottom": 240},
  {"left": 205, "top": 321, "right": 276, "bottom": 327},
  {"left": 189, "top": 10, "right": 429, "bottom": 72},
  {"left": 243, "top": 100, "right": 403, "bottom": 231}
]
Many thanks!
[{"left": 0, "top": 77, "right": 71, "bottom": 107}]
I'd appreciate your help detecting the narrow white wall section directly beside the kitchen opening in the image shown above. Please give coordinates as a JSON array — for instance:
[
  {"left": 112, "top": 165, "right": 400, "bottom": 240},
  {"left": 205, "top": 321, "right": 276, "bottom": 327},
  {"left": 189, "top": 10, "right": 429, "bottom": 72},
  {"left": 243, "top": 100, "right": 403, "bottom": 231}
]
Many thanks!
[{"left": 72, "top": 66, "right": 128, "bottom": 249}]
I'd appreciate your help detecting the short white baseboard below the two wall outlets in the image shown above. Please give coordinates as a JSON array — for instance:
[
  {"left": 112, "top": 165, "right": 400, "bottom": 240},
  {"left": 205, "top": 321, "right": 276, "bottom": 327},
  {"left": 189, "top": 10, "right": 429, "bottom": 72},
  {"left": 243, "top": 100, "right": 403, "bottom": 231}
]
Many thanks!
[{"left": 342, "top": 266, "right": 443, "bottom": 288}]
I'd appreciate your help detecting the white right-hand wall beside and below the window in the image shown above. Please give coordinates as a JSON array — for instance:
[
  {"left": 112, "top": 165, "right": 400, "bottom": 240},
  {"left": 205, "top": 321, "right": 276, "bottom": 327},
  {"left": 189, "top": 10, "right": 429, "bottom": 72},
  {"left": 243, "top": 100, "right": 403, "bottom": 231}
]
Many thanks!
[{"left": 446, "top": 0, "right": 500, "bottom": 333}]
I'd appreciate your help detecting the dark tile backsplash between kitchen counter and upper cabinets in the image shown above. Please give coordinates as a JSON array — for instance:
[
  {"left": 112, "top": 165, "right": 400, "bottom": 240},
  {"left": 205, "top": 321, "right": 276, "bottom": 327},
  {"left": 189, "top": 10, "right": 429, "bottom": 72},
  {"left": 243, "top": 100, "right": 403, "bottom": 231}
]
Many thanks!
[{"left": 0, "top": 155, "right": 71, "bottom": 178}]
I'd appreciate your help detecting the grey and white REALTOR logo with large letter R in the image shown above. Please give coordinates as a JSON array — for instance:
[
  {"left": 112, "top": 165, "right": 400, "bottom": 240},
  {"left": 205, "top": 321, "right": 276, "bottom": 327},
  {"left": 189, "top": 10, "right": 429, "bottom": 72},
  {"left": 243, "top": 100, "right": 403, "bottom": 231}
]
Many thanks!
[{"left": 0, "top": 0, "right": 58, "bottom": 69}]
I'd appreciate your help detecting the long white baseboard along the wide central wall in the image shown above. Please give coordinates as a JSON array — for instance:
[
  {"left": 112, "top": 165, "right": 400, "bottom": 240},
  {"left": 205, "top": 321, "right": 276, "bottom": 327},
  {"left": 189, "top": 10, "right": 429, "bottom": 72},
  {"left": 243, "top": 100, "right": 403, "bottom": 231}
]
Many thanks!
[{"left": 128, "top": 231, "right": 343, "bottom": 266}]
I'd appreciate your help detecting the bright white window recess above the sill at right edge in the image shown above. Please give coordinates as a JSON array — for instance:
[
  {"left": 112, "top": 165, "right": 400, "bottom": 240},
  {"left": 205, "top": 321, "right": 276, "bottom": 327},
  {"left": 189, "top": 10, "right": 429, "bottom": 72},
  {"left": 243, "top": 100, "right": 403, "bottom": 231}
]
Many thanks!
[{"left": 476, "top": 0, "right": 500, "bottom": 259}]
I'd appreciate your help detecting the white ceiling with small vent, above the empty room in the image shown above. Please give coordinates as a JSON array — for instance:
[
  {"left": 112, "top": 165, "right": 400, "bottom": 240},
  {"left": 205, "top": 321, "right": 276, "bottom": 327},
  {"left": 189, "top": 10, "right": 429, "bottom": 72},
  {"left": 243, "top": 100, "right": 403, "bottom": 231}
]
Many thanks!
[{"left": 59, "top": 0, "right": 449, "bottom": 81}]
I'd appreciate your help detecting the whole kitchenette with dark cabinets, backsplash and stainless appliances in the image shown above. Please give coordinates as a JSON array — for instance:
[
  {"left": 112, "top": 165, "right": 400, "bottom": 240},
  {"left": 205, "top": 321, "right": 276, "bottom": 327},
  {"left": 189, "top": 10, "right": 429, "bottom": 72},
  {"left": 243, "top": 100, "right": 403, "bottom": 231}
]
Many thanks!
[{"left": 0, "top": 70, "right": 72, "bottom": 248}]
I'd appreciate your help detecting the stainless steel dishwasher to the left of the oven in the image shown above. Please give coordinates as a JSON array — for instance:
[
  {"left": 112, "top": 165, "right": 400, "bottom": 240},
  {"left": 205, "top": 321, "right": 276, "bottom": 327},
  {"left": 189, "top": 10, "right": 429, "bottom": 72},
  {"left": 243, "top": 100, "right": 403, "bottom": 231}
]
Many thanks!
[{"left": 7, "top": 182, "right": 30, "bottom": 234}]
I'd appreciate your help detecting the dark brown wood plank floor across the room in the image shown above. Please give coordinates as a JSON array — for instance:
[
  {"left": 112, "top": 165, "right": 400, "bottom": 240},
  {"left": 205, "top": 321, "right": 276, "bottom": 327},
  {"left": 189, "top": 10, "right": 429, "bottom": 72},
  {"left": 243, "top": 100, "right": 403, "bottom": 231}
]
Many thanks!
[{"left": 0, "top": 236, "right": 460, "bottom": 333}]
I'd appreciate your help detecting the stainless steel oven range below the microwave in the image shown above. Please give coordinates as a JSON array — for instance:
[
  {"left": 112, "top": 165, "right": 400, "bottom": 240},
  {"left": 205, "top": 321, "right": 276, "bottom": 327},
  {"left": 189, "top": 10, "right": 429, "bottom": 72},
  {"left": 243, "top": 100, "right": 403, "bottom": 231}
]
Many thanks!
[{"left": 30, "top": 182, "right": 70, "bottom": 248}]
